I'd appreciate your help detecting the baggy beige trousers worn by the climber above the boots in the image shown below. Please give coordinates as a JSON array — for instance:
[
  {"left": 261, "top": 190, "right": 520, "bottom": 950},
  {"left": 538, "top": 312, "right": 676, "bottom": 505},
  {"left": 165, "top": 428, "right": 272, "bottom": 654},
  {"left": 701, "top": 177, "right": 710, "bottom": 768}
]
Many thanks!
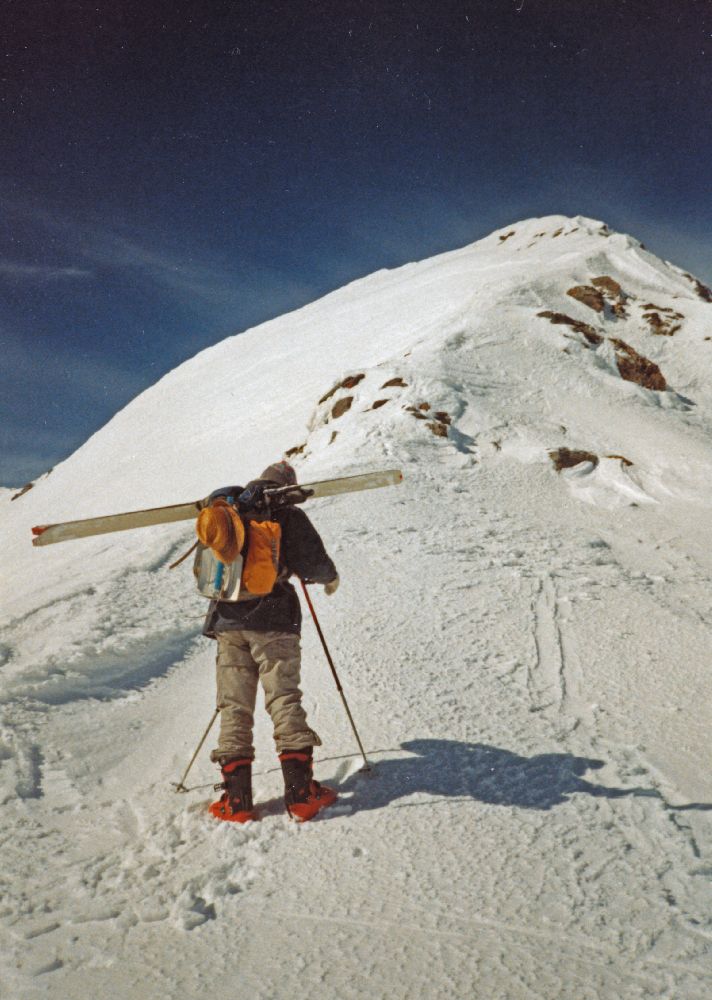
[{"left": 210, "top": 629, "right": 321, "bottom": 761}]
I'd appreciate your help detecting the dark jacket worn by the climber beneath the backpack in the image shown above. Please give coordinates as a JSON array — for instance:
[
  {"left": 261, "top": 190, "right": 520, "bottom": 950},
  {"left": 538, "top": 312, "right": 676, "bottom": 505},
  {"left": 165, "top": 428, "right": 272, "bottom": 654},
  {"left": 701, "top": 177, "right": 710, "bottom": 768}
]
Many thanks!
[{"left": 203, "top": 507, "right": 336, "bottom": 639}]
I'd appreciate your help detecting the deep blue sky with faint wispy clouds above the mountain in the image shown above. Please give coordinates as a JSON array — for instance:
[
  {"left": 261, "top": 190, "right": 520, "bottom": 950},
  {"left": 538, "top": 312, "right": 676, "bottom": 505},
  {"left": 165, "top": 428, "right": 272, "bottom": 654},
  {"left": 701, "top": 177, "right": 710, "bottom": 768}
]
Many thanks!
[{"left": 0, "top": 0, "right": 712, "bottom": 486}]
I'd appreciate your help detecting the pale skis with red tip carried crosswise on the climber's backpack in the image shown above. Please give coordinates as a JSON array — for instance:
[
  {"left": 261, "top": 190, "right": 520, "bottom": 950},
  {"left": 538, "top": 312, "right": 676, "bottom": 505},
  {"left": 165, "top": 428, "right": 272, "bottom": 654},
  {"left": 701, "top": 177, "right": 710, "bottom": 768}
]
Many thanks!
[{"left": 32, "top": 469, "right": 403, "bottom": 545}]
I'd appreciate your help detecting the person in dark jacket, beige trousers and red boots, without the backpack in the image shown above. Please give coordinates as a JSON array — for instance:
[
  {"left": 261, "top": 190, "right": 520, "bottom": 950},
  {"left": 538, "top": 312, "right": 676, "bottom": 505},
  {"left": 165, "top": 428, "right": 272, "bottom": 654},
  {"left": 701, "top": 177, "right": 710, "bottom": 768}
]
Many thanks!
[{"left": 198, "top": 461, "right": 339, "bottom": 823}]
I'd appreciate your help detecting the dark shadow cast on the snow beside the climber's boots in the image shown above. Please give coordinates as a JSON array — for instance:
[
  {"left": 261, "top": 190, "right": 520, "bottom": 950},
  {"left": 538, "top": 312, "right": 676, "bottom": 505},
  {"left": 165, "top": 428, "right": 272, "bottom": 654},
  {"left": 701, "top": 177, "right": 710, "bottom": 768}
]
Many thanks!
[{"left": 339, "top": 739, "right": 661, "bottom": 811}]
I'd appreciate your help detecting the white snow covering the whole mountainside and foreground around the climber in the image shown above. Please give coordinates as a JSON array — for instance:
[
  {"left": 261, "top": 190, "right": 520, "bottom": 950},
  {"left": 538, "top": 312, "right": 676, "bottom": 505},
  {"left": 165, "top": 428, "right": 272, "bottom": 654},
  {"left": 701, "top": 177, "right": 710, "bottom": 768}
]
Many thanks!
[{"left": 0, "top": 216, "right": 712, "bottom": 1000}]
